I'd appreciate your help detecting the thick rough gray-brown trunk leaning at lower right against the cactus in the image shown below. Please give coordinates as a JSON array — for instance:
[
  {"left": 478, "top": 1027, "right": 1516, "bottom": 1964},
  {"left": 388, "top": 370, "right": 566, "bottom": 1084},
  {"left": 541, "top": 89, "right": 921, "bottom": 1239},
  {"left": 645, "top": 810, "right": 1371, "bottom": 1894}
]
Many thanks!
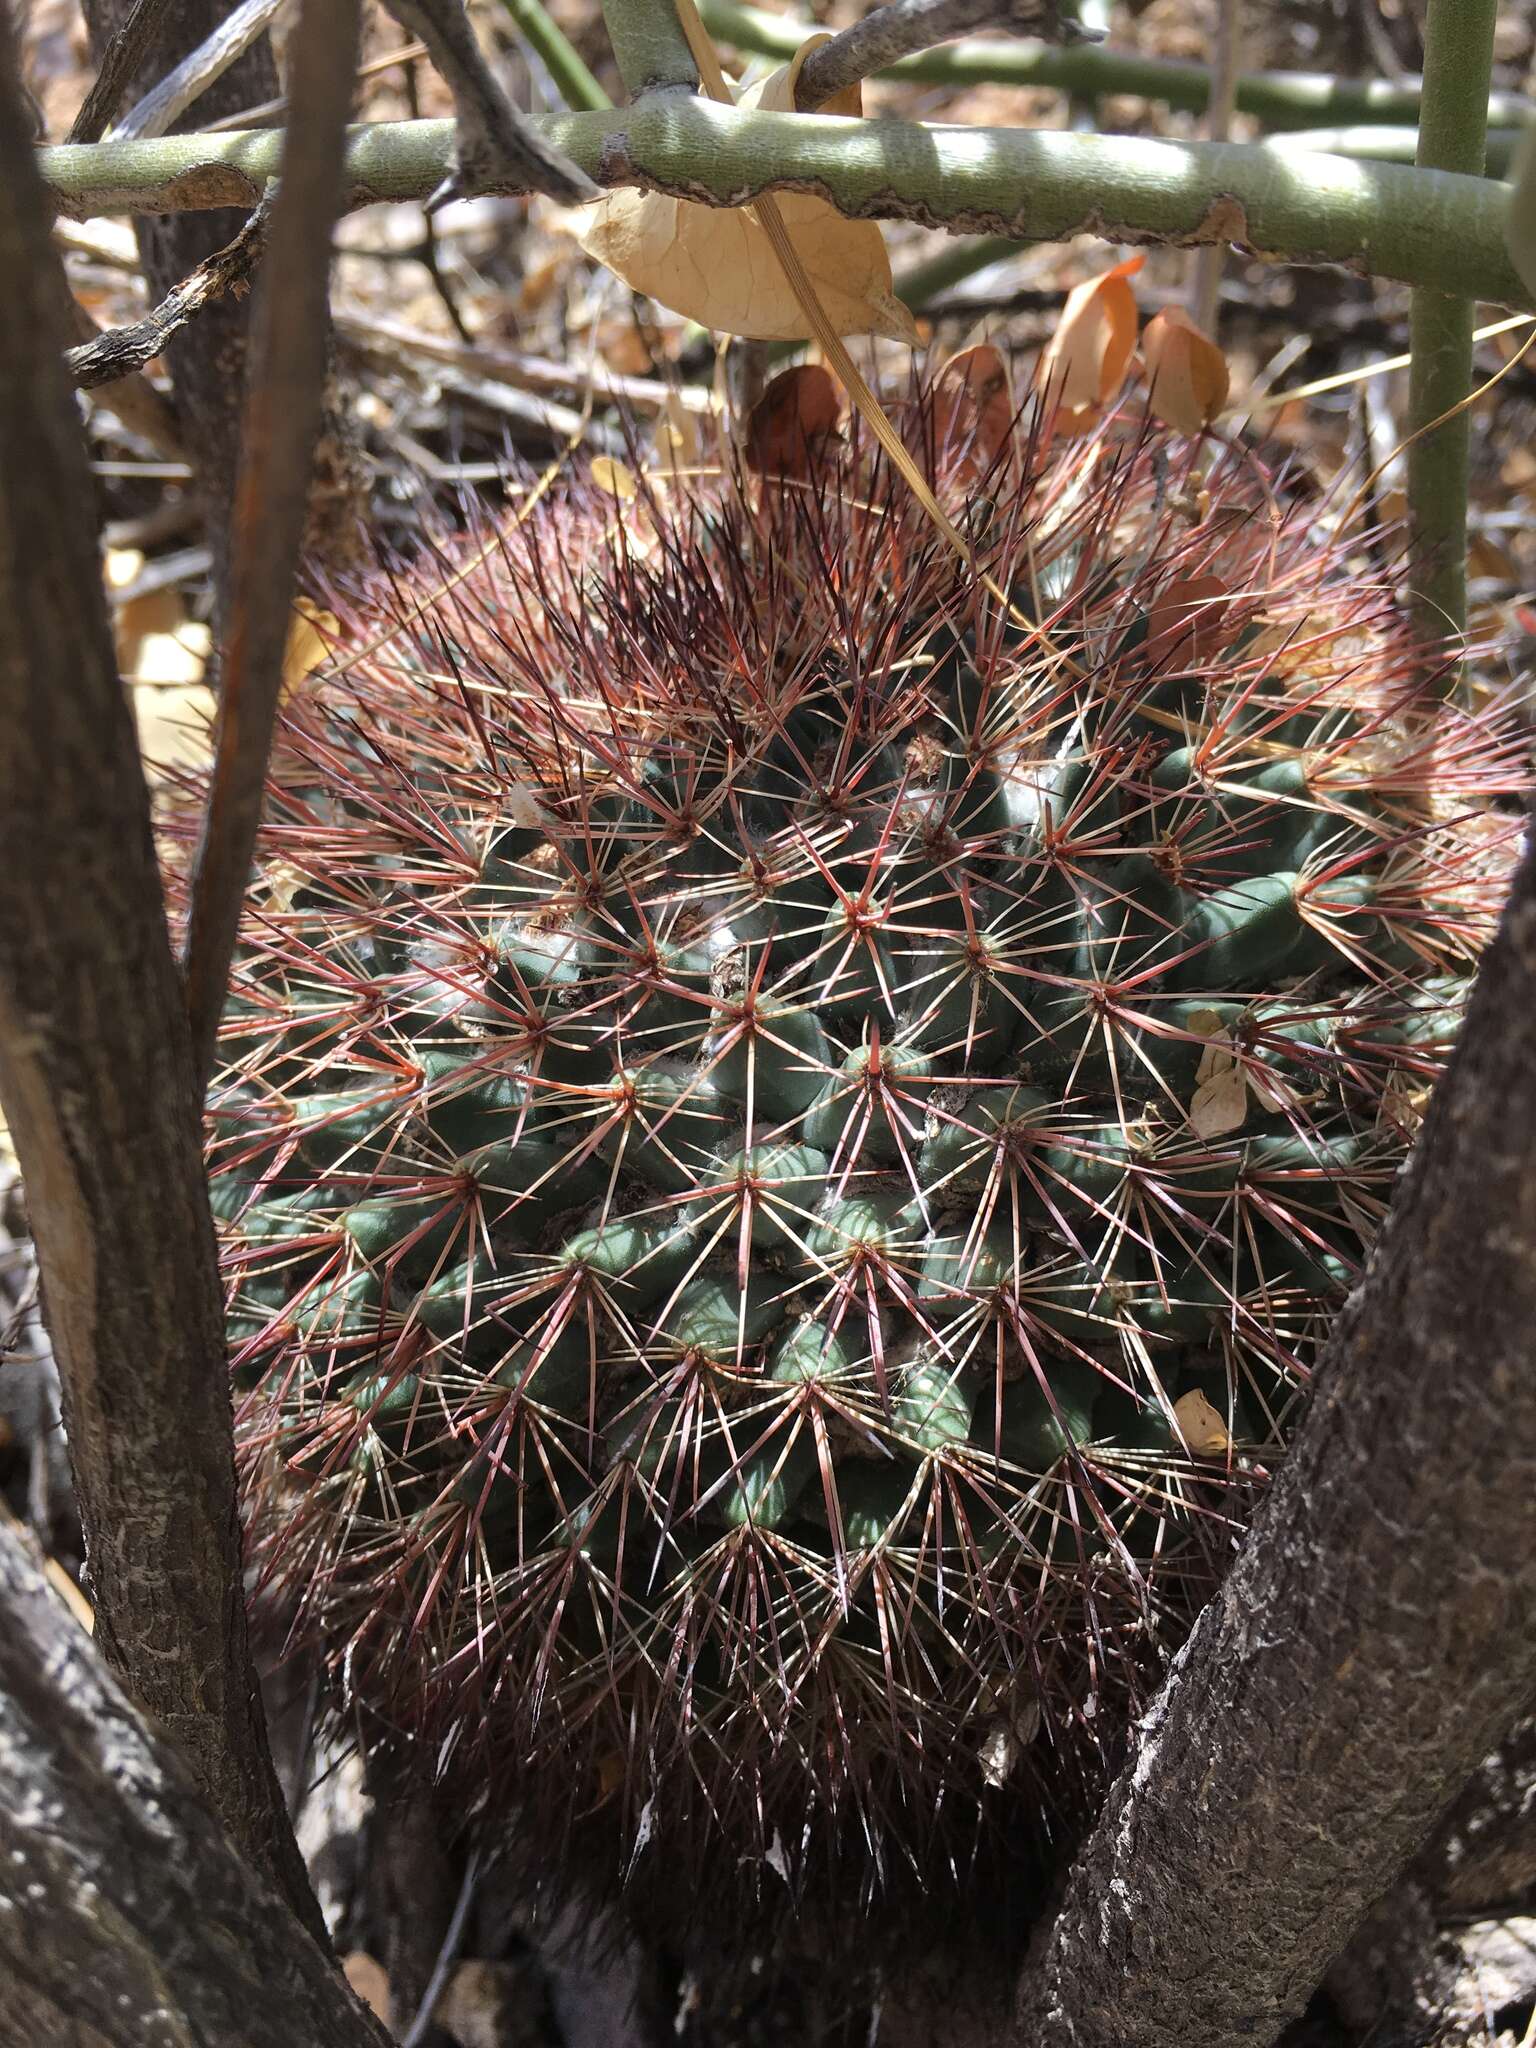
[{"left": 1016, "top": 827, "right": 1536, "bottom": 2048}]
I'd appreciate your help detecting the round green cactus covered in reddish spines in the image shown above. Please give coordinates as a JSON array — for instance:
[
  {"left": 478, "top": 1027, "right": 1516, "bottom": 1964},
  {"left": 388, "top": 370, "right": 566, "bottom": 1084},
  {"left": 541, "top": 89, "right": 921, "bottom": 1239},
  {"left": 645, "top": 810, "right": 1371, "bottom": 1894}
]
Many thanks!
[{"left": 177, "top": 364, "right": 1524, "bottom": 1898}]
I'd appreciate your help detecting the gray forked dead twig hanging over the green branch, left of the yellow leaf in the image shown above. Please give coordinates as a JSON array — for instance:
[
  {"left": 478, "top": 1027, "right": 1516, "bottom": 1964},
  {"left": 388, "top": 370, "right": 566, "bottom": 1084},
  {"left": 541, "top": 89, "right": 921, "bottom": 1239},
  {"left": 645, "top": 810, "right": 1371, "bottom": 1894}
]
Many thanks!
[{"left": 385, "top": 0, "right": 598, "bottom": 213}]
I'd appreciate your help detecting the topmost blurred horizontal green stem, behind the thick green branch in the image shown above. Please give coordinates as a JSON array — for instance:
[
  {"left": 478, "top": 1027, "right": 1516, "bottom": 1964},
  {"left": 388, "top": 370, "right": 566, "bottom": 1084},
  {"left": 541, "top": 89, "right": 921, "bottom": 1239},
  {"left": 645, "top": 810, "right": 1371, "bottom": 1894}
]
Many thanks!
[{"left": 698, "top": 0, "right": 1528, "bottom": 127}]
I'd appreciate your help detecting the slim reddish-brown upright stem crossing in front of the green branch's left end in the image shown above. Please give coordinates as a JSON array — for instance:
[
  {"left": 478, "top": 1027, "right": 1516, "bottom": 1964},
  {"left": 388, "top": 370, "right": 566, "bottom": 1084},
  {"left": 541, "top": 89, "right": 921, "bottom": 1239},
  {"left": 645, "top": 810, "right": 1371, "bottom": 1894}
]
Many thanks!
[{"left": 184, "top": 0, "right": 358, "bottom": 1085}]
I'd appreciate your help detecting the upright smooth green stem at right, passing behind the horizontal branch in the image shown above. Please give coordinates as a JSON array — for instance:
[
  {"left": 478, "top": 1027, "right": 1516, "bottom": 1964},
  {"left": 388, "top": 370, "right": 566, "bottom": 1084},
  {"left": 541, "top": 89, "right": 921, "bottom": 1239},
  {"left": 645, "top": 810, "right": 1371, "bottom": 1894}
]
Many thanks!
[{"left": 1407, "top": 0, "right": 1507, "bottom": 663}]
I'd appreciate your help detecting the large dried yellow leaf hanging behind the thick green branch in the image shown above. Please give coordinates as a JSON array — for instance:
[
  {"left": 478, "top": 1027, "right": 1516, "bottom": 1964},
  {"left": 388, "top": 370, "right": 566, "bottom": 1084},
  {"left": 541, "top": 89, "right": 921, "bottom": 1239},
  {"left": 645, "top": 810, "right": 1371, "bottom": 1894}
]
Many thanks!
[{"left": 578, "top": 35, "right": 920, "bottom": 348}]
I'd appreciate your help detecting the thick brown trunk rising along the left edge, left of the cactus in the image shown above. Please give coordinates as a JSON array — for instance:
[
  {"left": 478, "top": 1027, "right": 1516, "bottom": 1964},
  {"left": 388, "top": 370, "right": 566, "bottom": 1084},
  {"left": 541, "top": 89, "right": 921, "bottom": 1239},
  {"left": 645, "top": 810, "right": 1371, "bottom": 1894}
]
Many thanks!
[{"left": 0, "top": 8, "right": 324, "bottom": 1933}]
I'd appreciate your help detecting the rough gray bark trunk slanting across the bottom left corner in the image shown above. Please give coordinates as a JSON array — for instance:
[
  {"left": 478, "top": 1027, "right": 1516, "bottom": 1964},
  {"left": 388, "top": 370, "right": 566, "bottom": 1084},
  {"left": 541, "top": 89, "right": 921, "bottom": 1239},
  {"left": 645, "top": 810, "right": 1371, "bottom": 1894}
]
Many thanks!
[{"left": 0, "top": 1526, "right": 387, "bottom": 2048}]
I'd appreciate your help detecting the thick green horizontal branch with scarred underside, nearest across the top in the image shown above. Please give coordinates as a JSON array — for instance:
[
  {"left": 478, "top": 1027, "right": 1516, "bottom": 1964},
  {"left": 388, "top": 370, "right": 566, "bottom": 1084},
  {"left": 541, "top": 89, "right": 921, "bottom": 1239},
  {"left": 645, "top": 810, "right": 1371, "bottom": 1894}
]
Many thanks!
[{"left": 41, "top": 109, "right": 1536, "bottom": 311}]
